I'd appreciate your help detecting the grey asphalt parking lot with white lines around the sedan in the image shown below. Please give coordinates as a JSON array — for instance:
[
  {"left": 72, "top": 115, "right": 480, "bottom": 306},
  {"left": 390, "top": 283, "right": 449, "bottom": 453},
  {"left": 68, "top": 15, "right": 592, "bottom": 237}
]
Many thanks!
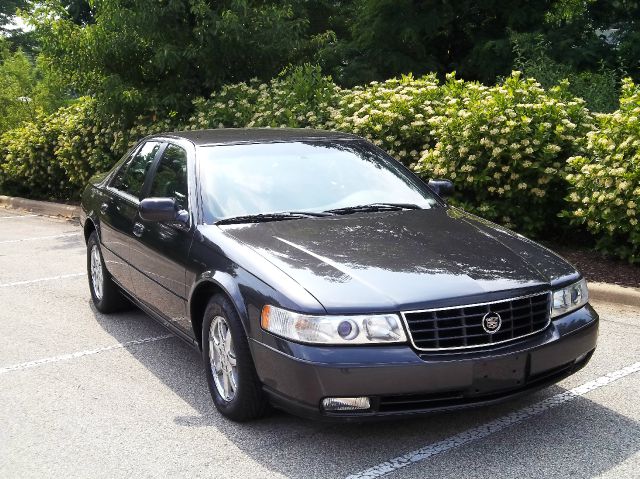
[{"left": 0, "top": 209, "right": 640, "bottom": 478}]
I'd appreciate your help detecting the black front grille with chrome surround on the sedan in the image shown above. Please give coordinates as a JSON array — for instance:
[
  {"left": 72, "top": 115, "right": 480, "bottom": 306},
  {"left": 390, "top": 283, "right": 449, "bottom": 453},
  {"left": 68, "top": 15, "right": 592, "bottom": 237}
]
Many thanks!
[{"left": 402, "top": 292, "right": 551, "bottom": 351}]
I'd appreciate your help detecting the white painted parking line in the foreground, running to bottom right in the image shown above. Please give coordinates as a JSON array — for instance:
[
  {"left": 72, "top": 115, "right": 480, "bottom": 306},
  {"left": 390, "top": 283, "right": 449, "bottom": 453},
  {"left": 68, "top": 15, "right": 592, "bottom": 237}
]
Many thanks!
[{"left": 347, "top": 362, "right": 640, "bottom": 479}]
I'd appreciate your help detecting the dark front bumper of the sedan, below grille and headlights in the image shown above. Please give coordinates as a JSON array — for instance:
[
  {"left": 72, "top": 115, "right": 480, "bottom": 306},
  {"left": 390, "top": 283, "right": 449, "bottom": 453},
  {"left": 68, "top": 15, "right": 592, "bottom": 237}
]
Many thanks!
[{"left": 251, "top": 305, "right": 598, "bottom": 420}]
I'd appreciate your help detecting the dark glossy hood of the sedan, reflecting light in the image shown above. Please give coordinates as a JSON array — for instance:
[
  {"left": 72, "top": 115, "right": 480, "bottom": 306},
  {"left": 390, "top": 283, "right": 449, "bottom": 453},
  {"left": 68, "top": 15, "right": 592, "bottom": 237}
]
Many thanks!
[{"left": 221, "top": 207, "right": 578, "bottom": 312}]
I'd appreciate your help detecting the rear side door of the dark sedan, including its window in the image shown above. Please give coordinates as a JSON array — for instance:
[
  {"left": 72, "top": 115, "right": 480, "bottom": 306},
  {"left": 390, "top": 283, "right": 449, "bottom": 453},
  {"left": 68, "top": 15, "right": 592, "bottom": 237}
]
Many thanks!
[{"left": 98, "top": 140, "right": 162, "bottom": 294}]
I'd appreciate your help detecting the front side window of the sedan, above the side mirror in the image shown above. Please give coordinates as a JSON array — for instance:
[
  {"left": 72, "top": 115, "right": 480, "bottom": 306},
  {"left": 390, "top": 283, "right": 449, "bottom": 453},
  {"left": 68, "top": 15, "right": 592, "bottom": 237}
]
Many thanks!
[{"left": 149, "top": 145, "right": 188, "bottom": 210}]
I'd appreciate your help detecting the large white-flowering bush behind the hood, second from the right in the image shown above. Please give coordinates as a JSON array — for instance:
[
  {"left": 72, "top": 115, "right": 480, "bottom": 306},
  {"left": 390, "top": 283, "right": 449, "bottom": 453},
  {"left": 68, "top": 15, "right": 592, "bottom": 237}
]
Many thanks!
[{"left": 415, "top": 72, "right": 593, "bottom": 236}]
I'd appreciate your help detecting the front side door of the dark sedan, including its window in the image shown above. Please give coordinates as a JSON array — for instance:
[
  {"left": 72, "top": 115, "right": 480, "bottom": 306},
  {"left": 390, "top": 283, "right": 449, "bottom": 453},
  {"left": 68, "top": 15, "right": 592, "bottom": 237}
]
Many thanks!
[{"left": 126, "top": 143, "right": 193, "bottom": 335}]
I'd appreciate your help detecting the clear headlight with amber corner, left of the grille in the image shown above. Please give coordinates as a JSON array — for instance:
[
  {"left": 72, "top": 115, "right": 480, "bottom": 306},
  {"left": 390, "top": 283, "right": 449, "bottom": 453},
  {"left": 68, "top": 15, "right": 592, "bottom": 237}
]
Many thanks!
[{"left": 260, "top": 305, "right": 407, "bottom": 344}]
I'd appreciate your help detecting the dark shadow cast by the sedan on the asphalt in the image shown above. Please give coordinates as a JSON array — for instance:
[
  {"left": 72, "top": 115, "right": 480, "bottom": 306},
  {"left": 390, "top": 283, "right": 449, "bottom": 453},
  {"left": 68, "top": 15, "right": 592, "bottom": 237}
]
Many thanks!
[{"left": 88, "top": 301, "right": 640, "bottom": 479}]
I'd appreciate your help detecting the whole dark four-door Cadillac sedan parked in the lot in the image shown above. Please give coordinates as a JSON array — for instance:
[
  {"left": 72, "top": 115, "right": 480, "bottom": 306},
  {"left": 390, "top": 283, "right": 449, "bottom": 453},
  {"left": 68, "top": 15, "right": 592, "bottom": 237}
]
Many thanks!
[{"left": 81, "top": 128, "right": 598, "bottom": 421}]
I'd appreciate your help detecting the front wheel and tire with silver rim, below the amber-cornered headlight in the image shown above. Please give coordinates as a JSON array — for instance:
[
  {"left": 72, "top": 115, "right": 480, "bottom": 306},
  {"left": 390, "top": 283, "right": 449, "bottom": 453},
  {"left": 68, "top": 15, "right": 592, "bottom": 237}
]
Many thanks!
[{"left": 202, "top": 294, "right": 269, "bottom": 422}]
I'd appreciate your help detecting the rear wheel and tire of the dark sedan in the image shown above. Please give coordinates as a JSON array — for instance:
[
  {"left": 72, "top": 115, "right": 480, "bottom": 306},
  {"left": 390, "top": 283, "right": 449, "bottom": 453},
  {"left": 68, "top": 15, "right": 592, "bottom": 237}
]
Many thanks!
[{"left": 87, "top": 231, "right": 131, "bottom": 314}]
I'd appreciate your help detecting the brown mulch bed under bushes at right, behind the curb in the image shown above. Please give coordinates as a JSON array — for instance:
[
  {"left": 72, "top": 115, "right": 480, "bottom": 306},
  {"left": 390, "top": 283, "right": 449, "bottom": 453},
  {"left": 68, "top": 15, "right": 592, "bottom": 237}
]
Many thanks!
[{"left": 546, "top": 244, "right": 640, "bottom": 288}]
